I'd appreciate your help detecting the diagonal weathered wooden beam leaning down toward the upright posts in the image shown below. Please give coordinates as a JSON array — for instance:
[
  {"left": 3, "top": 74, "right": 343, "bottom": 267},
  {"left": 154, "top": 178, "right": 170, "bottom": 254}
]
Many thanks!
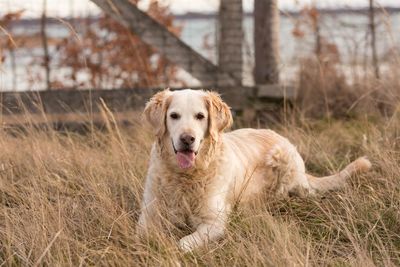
[{"left": 92, "top": 0, "right": 240, "bottom": 87}]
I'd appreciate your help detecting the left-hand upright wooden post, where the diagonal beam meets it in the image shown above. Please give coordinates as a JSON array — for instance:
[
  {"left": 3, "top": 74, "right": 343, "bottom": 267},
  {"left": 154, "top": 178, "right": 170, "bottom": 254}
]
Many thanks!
[{"left": 218, "top": 0, "right": 243, "bottom": 83}]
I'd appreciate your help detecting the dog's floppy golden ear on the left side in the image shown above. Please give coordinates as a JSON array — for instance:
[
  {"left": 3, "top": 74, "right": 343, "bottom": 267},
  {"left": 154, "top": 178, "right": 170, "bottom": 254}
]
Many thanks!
[{"left": 143, "top": 89, "right": 172, "bottom": 138}]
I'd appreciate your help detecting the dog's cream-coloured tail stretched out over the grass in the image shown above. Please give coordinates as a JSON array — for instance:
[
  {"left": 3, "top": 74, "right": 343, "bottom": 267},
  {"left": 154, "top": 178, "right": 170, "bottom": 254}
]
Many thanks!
[{"left": 307, "top": 157, "right": 372, "bottom": 192}]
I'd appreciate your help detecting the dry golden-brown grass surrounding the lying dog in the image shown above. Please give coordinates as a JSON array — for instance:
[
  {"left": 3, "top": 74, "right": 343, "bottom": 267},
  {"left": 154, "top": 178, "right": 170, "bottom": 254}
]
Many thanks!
[{"left": 0, "top": 108, "right": 400, "bottom": 266}]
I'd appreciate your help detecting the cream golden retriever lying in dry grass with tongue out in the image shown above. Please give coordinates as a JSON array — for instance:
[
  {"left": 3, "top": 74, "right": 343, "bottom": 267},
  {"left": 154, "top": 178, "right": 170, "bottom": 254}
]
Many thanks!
[{"left": 138, "top": 89, "right": 371, "bottom": 251}]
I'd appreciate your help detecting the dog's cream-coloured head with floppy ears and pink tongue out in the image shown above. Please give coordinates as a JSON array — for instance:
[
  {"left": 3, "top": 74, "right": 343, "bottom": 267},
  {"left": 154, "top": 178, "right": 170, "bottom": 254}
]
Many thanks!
[{"left": 144, "top": 89, "right": 232, "bottom": 169}]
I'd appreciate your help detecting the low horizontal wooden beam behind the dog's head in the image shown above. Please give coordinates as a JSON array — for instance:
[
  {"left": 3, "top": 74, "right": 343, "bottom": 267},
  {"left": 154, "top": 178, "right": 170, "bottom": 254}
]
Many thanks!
[{"left": 0, "top": 87, "right": 253, "bottom": 115}]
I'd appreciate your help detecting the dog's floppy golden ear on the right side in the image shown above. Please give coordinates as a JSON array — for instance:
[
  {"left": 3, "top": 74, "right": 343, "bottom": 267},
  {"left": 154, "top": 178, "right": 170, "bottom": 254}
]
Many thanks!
[{"left": 206, "top": 92, "right": 233, "bottom": 140}]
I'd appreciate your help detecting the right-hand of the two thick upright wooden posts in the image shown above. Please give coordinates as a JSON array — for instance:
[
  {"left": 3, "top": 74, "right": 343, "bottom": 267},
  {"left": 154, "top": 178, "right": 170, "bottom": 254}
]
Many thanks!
[{"left": 254, "top": 0, "right": 279, "bottom": 84}]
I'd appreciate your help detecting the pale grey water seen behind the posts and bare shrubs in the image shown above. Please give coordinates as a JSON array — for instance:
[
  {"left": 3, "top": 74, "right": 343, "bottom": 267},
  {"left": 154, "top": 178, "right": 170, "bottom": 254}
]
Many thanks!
[{"left": 0, "top": 13, "right": 400, "bottom": 91}]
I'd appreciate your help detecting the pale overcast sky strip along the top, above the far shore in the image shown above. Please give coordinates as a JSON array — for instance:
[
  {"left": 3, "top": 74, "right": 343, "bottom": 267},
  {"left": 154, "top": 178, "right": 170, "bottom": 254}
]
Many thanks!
[{"left": 0, "top": 0, "right": 400, "bottom": 17}]
